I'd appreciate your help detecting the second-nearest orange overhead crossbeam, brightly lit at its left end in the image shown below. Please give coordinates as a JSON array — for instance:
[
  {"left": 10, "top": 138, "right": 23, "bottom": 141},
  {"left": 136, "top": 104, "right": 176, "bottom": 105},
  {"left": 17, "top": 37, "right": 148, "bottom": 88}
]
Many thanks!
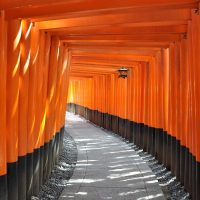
[{"left": 38, "top": 9, "right": 191, "bottom": 30}]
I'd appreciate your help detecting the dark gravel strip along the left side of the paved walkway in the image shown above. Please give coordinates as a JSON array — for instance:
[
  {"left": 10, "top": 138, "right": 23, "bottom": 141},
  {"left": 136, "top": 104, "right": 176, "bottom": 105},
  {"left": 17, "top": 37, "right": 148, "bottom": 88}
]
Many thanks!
[{"left": 31, "top": 131, "right": 77, "bottom": 200}]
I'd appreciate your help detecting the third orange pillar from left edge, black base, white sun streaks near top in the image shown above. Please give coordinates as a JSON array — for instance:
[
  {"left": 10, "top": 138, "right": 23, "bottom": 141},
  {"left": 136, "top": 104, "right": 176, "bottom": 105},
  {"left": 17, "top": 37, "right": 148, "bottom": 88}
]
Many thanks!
[{"left": 18, "top": 20, "right": 32, "bottom": 200}]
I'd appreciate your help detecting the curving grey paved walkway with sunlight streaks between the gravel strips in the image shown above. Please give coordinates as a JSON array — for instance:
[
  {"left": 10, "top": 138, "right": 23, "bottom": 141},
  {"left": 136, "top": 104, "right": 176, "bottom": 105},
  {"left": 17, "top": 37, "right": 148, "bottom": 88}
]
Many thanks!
[{"left": 59, "top": 114, "right": 165, "bottom": 200}]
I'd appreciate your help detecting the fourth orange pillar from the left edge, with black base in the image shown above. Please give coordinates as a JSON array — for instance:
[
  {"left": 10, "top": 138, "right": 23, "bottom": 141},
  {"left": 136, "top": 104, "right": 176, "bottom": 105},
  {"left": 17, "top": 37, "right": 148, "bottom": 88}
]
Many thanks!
[{"left": 26, "top": 23, "right": 39, "bottom": 199}]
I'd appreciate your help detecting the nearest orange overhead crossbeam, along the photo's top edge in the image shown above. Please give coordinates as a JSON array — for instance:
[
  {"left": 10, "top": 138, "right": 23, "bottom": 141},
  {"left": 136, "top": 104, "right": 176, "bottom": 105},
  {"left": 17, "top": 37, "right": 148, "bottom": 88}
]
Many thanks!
[{"left": 3, "top": 0, "right": 197, "bottom": 21}]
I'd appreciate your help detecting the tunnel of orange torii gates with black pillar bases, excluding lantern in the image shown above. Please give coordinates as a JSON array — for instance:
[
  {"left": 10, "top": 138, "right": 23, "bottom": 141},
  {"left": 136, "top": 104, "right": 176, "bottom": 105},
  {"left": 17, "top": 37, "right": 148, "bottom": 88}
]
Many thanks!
[{"left": 0, "top": 0, "right": 200, "bottom": 200}]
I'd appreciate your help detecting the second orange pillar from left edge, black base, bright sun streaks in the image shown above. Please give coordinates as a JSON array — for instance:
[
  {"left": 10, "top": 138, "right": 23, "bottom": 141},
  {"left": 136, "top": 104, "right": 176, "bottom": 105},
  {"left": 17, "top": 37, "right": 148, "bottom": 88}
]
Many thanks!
[{"left": 6, "top": 20, "right": 22, "bottom": 200}]
